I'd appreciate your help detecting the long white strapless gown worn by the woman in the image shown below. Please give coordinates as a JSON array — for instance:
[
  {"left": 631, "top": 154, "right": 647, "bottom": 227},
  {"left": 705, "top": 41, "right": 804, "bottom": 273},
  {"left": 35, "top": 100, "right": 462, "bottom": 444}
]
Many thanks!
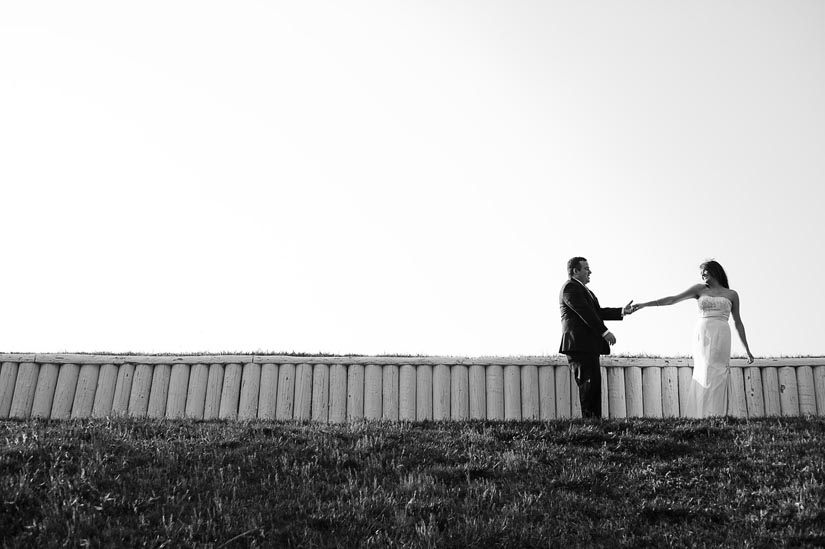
[{"left": 685, "top": 295, "right": 731, "bottom": 417}]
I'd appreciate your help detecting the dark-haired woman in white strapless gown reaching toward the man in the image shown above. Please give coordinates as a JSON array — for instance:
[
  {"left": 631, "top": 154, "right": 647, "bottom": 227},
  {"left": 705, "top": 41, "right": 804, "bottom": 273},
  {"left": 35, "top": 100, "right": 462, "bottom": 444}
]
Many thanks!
[{"left": 633, "top": 261, "right": 753, "bottom": 417}]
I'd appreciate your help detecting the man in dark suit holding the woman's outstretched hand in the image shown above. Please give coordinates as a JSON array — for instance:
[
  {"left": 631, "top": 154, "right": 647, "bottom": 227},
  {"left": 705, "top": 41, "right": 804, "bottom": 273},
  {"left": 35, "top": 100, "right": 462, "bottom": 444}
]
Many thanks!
[{"left": 559, "top": 257, "right": 633, "bottom": 417}]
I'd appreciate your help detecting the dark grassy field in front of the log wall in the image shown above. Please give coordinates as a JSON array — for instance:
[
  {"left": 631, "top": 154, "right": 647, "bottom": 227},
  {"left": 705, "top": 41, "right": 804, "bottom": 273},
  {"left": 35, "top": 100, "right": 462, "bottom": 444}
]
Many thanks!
[{"left": 0, "top": 418, "right": 825, "bottom": 547}]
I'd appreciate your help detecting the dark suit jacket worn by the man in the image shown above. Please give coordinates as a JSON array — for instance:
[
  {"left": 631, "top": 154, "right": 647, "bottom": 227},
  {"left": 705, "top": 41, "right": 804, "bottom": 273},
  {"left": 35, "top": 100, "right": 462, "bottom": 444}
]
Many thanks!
[{"left": 559, "top": 278, "right": 622, "bottom": 355}]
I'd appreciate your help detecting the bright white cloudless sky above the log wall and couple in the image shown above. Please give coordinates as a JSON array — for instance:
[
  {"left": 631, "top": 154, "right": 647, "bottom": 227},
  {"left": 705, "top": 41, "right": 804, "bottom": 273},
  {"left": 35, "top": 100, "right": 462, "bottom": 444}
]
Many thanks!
[{"left": 0, "top": 0, "right": 825, "bottom": 356}]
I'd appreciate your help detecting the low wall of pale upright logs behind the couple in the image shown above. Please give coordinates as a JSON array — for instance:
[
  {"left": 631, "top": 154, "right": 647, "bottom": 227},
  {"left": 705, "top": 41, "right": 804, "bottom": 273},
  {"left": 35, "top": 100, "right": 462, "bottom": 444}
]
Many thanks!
[{"left": 0, "top": 354, "right": 825, "bottom": 423}]
